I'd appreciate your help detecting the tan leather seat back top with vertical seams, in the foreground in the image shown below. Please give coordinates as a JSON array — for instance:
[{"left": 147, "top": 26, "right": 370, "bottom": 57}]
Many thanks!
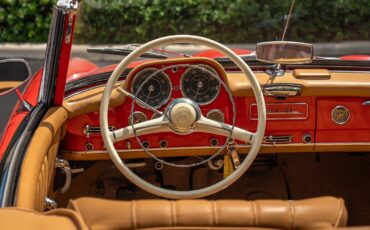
[{"left": 68, "top": 197, "right": 347, "bottom": 229}]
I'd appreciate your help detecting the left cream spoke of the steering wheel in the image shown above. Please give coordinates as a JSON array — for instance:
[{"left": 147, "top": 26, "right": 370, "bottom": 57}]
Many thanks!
[{"left": 109, "top": 116, "right": 171, "bottom": 142}]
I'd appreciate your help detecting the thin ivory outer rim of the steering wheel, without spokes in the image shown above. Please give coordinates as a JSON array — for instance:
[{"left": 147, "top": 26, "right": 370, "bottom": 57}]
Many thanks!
[{"left": 100, "top": 35, "right": 266, "bottom": 199}]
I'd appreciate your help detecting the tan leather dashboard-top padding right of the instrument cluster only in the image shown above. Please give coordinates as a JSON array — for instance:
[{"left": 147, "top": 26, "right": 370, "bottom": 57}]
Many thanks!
[{"left": 226, "top": 71, "right": 370, "bottom": 97}]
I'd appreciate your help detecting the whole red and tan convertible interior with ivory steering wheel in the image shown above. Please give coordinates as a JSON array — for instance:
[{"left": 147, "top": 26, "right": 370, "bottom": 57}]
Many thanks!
[{"left": 0, "top": 0, "right": 370, "bottom": 229}]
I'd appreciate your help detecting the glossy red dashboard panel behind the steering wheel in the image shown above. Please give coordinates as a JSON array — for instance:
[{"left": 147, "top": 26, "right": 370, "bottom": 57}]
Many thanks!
[{"left": 61, "top": 58, "right": 370, "bottom": 160}]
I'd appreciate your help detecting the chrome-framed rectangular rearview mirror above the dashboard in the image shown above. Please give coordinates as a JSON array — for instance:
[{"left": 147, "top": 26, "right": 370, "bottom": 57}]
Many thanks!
[{"left": 256, "top": 41, "right": 313, "bottom": 64}]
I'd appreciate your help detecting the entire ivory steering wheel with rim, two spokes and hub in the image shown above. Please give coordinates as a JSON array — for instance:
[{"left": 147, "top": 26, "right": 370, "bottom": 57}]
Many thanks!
[{"left": 100, "top": 35, "right": 266, "bottom": 199}]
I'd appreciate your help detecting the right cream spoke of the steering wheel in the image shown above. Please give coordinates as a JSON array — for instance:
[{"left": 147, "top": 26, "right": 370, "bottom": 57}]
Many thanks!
[{"left": 194, "top": 116, "right": 256, "bottom": 145}]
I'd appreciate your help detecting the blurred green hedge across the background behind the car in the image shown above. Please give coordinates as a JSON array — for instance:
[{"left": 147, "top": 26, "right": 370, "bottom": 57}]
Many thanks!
[{"left": 0, "top": 0, "right": 370, "bottom": 44}]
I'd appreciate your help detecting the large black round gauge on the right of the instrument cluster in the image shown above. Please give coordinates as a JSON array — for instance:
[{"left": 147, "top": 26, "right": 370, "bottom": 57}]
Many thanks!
[{"left": 181, "top": 67, "right": 220, "bottom": 105}]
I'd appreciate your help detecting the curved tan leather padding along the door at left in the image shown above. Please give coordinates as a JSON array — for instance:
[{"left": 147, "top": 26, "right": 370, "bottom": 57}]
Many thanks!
[{"left": 16, "top": 107, "right": 67, "bottom": 211}]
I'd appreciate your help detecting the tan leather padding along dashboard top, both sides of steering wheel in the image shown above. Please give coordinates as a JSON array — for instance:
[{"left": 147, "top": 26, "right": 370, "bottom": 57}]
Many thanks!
[{"left": 63, "top": 70, "right": 370, "bottom": 118}]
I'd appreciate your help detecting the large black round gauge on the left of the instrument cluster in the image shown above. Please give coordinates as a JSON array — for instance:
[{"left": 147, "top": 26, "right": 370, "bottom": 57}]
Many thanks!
[{"left": 131, "top": 69, "right": 172, "bottom": 108}]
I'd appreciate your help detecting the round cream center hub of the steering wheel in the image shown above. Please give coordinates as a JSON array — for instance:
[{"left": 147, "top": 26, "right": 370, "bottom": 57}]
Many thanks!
[{"left": 167, "top": 98, "right": 201, "bottom": 133}]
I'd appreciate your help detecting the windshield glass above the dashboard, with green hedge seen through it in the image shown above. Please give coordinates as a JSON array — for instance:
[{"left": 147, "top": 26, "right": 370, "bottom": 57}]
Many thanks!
[{"left": 71, "top": 0, "right": 370, "bottom": 61}]
